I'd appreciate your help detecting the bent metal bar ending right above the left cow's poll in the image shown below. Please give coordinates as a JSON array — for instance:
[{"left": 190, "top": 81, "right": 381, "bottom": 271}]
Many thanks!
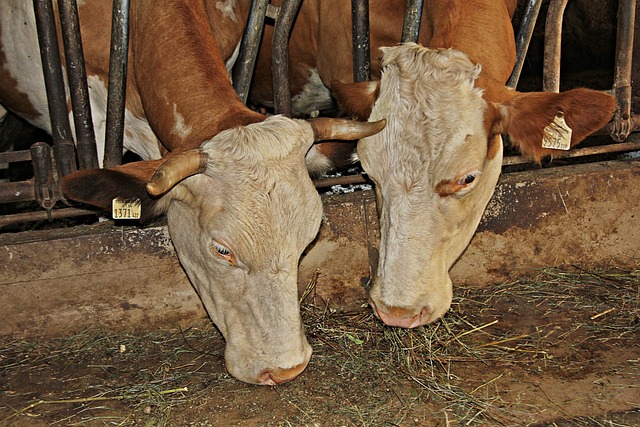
[{"left": 271, "top": 0, "right": 302, "bottom": 117}]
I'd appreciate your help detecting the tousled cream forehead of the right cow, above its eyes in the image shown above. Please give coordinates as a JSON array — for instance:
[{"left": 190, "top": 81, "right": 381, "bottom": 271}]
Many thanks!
[{"left": 358, "top": 44, "right": 487, "bottom": 179}]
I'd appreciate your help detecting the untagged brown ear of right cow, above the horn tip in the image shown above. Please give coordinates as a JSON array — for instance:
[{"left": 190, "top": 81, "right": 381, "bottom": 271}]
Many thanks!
[{"left": 331, "top": 80, "right": 380, "bottom": 120}]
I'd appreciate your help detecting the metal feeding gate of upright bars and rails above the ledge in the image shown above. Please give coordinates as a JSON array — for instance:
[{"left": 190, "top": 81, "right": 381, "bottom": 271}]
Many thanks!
[{"left": 0, "top": 0, "right": 640, "bottom": 227}]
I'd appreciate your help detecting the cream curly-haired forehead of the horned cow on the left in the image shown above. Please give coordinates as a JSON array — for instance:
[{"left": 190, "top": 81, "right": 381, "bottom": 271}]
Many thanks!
[{"left": 177, "top": 117, "right": 322, "bottom": 270}]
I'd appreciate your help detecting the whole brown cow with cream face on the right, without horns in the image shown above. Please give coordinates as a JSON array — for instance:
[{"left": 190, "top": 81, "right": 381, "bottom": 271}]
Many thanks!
[{"left": 246, "top": 0, "right": 615, "bottom": 328}]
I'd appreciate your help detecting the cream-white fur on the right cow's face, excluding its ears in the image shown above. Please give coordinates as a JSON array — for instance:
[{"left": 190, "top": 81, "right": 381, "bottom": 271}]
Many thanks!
[{"left": 358, "top": 44, "right": 502, "bottom": 326}]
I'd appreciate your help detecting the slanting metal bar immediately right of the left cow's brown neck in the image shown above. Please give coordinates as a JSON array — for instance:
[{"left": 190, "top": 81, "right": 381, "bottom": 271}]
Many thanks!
[{"left": 233, "top": 0, "right": 269, "bottom": 104}]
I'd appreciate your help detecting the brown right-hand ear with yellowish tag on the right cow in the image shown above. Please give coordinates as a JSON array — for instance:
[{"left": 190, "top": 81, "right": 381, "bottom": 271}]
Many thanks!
[{"left": 492, "top": 88, "right": 616, "bottom": 161}]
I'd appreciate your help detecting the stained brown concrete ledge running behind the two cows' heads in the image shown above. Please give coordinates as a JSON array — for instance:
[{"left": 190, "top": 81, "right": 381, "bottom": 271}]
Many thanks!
[{"left": 0, "top": 160, "right": 640, "bottom": 336}]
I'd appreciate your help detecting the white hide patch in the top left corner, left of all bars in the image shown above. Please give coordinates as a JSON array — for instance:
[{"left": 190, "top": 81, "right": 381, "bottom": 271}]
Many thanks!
[{"left": 0, "top": 0, "right": 51, "bottom": 133}]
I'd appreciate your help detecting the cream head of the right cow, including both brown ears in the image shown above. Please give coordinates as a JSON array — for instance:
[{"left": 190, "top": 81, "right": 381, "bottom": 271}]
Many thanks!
[{"left": 333, "top": 43, "right": 614, "bottom": 327}]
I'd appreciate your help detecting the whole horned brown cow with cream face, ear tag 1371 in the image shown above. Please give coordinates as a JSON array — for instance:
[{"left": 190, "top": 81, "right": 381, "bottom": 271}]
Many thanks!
[{"left": 0, "top": 0, "right": 384, "bottom": 385}]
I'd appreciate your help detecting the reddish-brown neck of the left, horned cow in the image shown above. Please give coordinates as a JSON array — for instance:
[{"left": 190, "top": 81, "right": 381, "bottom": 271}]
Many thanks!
[{"left": 131, "top": 0, "right": 264, "bottom": 151}]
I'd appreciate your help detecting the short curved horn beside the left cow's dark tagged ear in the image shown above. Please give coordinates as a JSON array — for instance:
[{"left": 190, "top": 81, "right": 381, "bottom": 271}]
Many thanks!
[{"left": 147, "top": 149, "right": 207, "bottom": 196}]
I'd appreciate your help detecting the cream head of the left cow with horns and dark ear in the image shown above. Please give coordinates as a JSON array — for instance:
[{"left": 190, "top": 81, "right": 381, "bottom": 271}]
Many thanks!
[{"left": 63, "top": 116, "right": 384, "bottom": 385}]
